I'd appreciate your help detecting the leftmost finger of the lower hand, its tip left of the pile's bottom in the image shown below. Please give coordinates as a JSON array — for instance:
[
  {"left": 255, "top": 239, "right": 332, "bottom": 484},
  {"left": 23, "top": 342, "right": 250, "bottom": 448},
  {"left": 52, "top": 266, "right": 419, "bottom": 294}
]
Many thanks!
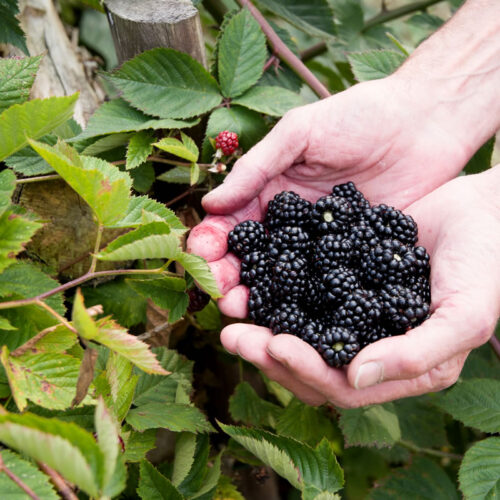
[{"left": 221, "top": 323, "right": 326, "bottom": 406}]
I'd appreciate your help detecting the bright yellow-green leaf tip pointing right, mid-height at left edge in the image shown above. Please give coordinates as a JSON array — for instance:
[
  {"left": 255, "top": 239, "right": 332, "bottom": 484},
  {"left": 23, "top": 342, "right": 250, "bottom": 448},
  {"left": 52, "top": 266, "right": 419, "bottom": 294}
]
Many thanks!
[{"left": 0, "top": 210, "right": 42, "bottom": 272}]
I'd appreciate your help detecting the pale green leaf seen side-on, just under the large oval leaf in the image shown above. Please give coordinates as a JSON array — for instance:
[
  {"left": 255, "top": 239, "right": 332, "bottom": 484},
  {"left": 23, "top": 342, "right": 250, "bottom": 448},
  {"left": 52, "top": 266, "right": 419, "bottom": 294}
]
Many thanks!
[{"left": 73, "top": 99, "right": 200, "bottom": 141}]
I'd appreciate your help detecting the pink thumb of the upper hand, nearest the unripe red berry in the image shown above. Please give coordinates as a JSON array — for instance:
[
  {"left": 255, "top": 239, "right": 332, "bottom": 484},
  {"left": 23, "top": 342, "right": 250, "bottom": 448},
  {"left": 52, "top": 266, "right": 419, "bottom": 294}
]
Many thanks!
[{"left": 203, "top": 107, "right": 307, "bottom": 214}]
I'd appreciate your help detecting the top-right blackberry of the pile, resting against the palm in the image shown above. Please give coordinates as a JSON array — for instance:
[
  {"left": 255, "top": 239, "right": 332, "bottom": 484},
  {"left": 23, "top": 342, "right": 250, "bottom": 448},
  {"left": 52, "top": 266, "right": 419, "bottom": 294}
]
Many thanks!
[{"left": 363, "top": 204, "right": 417, "bottom": 245}]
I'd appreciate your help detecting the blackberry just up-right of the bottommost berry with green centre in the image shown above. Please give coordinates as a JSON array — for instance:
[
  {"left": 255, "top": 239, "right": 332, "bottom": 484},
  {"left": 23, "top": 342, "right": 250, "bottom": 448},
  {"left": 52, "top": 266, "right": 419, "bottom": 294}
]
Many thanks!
[{"left": 334, "top": 288, "right": 382, "bottom": 338}]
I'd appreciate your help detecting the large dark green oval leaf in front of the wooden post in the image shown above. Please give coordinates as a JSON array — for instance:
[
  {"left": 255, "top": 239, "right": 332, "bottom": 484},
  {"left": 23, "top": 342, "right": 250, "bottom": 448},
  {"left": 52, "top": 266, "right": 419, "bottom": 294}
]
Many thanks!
[{"left": 107, "top": 48, "right": 222, "bottom": 118}]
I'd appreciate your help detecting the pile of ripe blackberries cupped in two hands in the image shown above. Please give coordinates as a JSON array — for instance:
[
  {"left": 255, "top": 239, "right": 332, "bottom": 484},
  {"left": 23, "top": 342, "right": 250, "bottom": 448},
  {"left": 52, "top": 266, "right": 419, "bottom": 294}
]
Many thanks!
[{"left": 228, "top": 182, "right": 430, "bottom": 367}]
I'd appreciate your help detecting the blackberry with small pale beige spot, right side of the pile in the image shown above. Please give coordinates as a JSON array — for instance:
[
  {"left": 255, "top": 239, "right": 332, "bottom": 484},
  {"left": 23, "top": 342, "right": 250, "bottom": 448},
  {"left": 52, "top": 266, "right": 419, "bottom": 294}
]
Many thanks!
[{"left": 360, "top": 240, "right": 417, "bottom": 286}]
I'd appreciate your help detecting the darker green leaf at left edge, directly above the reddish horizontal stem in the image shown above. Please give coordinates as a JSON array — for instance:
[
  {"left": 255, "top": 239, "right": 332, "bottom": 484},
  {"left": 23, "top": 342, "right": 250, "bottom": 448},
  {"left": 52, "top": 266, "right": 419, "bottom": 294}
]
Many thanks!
[{"left": 0, "top": 260, "right": 66, "bottom": 315}]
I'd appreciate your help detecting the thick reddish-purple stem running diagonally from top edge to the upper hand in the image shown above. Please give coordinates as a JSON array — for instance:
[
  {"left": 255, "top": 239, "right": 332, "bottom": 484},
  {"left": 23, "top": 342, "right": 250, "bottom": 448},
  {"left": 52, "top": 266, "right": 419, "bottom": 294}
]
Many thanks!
[{"left": 237, "top": 0, "right": 330, "bottom": 98}]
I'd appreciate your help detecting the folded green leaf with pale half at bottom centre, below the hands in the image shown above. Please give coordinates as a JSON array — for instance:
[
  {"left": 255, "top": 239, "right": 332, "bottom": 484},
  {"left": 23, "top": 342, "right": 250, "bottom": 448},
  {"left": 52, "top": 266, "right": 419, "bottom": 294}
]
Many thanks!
[{"left": 219, "top": 424, "right": 344, "bottom": 500}]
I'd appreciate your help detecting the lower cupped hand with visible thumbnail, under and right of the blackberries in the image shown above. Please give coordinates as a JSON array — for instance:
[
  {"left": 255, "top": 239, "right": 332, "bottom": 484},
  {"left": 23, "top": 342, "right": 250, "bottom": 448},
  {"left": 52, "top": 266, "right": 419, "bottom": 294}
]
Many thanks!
[{"left": 217, "top": 165, "right": 500, "bottom": 408}]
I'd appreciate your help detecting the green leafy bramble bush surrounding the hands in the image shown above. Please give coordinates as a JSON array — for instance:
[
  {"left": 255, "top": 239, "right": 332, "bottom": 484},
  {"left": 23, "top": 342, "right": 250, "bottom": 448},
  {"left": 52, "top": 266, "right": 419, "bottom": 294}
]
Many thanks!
[{"left": 0, "top": 0, "right": 500, "bottom": 500}]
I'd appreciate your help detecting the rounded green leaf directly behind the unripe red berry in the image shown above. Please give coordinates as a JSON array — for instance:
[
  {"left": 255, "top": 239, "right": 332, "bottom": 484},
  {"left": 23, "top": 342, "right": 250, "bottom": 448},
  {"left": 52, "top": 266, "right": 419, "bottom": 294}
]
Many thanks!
[{"left": 202, "top": 106, "right": 267, "bottom": 162}]
